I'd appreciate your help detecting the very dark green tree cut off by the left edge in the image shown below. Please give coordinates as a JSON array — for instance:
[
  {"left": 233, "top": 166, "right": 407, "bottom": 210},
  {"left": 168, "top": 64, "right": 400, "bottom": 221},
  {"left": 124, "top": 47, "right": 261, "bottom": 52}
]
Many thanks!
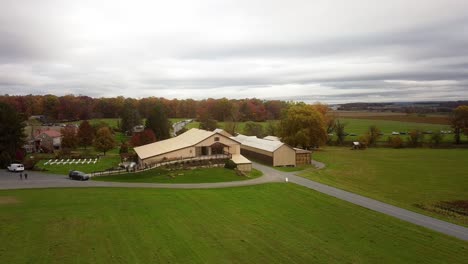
[{"left": 0, "top": 103, "right": 25, "bottom": 167}]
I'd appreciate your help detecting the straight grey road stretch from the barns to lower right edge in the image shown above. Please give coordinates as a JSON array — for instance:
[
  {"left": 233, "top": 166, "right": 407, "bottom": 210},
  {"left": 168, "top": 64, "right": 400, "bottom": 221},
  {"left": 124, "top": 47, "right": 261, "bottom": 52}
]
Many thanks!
[{"left": 255, "top": 164, "right": 468, "bottom": 241}]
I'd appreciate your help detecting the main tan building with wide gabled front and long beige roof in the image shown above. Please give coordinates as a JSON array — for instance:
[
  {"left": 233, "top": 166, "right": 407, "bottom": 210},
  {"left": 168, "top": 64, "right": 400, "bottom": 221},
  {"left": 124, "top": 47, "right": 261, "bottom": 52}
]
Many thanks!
[{"left": 135, "top": 128, "right": 252, "bottom": 171}]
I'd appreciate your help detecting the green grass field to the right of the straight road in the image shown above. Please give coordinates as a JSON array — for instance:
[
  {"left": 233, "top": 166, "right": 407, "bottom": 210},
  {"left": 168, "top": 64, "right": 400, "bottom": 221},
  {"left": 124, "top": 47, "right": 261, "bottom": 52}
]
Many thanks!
[{"left": 300, "top": 147, "right": 468, "bottom": 226}]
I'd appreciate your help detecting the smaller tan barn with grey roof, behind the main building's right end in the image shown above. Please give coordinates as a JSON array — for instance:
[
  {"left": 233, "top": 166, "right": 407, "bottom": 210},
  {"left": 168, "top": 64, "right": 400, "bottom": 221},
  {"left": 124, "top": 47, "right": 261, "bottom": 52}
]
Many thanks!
[{"left": 231, "top": 134, "right": 311, "bottom": 167}]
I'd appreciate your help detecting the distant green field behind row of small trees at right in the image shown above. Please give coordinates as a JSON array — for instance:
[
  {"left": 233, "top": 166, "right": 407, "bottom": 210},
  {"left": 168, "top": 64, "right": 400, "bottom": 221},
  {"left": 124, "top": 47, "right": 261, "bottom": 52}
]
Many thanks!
[{"left": 340, "top": 118, "right": 467, "bottom": 142}]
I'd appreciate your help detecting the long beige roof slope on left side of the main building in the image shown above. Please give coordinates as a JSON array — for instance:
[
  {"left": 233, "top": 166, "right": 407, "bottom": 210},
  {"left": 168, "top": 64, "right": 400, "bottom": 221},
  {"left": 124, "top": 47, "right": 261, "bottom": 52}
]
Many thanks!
[{"left": 134, "top": 128, "right": 225, "bottom": 159}]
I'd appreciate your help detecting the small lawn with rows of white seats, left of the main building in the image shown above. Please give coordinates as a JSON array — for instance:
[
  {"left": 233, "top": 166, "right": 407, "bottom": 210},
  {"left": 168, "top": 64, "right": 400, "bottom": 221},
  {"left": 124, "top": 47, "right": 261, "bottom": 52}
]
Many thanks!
[{"left": 36, "top": 154, "right": 120, "bottom": 175}]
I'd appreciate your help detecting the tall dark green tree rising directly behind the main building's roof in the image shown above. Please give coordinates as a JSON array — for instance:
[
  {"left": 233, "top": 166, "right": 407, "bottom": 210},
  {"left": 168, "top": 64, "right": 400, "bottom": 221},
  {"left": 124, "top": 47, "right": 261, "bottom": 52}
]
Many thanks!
[{"left": 146, "top": 103, "right": 171, "bottom": 140}]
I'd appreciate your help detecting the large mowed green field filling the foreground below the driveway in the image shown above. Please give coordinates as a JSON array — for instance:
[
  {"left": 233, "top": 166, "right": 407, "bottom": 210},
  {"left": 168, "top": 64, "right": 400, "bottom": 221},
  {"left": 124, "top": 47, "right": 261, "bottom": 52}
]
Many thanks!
[{"left": 0, "top": 184, "right": 468, "bottom": 264}]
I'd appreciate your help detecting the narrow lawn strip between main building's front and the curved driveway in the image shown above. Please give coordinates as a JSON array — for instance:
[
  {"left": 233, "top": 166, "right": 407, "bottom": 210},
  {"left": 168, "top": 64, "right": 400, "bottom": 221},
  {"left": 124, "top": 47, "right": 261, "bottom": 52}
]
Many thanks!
[{"left": 93, "top": 168, "right": 262, "bottom": 183}]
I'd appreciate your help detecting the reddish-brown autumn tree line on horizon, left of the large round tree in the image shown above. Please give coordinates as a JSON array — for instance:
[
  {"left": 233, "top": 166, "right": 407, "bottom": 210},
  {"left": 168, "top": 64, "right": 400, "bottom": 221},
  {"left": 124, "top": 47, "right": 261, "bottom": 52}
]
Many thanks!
[{"left": 0, "top": 94, "right": 290, "bottom": 122}]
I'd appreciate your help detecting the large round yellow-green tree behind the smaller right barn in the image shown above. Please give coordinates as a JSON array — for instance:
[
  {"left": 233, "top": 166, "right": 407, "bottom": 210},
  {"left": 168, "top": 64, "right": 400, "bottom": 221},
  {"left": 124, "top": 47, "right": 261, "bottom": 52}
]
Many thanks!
[{"left": 279, "top": 103, "right": 327, "bottom": 148}]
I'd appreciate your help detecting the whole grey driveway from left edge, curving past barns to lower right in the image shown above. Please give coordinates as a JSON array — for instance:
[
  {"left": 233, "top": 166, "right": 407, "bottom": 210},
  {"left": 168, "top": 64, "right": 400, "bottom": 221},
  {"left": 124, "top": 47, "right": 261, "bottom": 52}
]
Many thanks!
[{"left": 0, "top": 163, "right": 468, "bottom": 241}]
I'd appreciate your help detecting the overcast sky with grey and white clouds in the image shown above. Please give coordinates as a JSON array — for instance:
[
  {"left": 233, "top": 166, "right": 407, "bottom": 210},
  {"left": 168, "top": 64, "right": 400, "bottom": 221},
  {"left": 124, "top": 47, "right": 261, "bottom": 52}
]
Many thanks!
[{"left": 0, "top": 0, "right": 468, "bottom": 103}]
